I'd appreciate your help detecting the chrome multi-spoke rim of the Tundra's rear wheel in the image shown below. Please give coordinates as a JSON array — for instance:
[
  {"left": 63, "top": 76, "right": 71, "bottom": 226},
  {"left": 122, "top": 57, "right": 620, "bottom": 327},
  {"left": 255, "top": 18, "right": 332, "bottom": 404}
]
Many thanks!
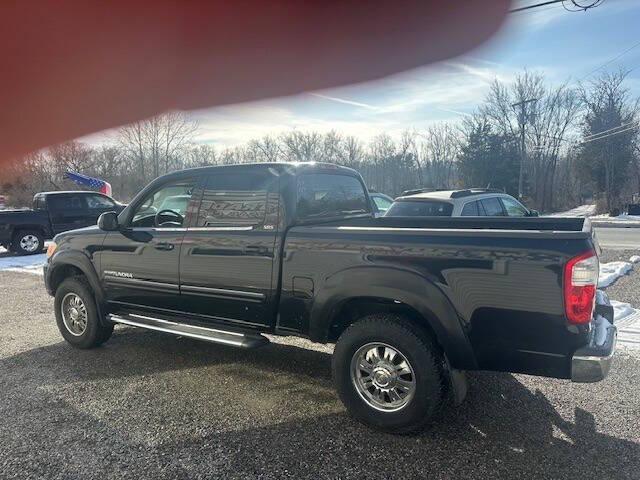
[{"left": 351, "top": 342, "right": 416, "bottom": 412}]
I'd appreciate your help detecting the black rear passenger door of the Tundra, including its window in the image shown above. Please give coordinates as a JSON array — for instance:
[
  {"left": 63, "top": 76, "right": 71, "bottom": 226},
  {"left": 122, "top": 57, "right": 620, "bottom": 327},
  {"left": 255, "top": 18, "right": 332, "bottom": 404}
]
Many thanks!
[{"left": 180, "top": 168, "right": 279, "bottom": 327}]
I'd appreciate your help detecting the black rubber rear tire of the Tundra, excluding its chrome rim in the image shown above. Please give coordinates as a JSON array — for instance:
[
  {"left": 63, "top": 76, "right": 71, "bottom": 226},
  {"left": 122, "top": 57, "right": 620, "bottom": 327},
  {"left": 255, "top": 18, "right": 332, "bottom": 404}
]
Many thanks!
[{"left": 332, "top": 314, "right": 446, "bottom": 434}]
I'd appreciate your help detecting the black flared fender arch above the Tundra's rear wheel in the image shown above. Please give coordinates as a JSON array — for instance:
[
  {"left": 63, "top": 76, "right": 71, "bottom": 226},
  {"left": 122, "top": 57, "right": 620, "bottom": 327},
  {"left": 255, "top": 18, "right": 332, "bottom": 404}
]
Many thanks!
[{"left": 309, "top": 267, "right": 477, "bottom": 369}]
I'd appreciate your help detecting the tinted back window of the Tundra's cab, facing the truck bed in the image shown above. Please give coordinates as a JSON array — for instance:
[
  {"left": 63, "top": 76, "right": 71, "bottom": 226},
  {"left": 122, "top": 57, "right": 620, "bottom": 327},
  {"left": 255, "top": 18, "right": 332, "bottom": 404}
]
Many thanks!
[{"left": 297, "top": 173, "right": 371, "bottom": 219}]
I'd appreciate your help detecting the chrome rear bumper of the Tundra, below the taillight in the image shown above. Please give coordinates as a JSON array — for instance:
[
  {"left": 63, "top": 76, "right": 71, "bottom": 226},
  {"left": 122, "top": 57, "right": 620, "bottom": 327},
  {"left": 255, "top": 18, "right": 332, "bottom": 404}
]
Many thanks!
[{"left": 571, "top": 315, "right": 617, "bottom": 383}]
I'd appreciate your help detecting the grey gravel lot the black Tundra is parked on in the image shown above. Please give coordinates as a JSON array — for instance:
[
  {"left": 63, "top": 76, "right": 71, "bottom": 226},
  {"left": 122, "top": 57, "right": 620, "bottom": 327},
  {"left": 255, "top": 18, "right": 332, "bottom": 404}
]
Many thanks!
[{"left": 0, "top": 264, "right": 640, "bottom": 479}]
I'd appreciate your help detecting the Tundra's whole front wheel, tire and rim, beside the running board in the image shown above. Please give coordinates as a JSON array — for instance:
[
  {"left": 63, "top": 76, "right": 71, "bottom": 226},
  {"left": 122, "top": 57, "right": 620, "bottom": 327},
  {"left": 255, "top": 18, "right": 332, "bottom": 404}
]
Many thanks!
[{"left": 54, "top": 277, "right": 113, "bottom": 348}]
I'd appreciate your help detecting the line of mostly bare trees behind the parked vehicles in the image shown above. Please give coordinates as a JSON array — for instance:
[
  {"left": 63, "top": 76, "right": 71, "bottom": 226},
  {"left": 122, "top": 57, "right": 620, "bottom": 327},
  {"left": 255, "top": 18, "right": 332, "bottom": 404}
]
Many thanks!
[{"left": 5, "top": 71, "right": 640, "bottom": 211}]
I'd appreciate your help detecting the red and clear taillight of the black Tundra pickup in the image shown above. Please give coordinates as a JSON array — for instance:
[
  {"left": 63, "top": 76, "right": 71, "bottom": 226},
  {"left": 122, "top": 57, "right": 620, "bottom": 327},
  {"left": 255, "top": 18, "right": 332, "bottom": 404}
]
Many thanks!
[{"left": 564, "top": 252, "right": 599, "bottom": 324}]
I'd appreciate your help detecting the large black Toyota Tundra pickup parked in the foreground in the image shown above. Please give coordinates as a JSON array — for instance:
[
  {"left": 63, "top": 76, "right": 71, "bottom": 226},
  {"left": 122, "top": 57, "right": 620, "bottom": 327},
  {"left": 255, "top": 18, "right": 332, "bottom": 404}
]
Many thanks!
[{"left": 44, "top": 163, "right": 616, "bottom": 432}]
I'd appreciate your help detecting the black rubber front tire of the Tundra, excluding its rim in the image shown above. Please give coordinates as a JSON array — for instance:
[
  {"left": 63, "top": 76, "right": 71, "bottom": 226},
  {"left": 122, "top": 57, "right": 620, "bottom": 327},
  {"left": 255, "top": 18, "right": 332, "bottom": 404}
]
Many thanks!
[{"left": 54, "top": 277, "right": 113, "bottom": 349}]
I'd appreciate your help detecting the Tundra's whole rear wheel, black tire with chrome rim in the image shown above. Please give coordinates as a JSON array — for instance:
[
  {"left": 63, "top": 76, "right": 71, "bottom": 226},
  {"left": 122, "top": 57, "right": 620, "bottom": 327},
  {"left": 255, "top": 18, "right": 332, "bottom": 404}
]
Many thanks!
[{"left": 332, "top": 314, "right": 445, "bottom": 433}]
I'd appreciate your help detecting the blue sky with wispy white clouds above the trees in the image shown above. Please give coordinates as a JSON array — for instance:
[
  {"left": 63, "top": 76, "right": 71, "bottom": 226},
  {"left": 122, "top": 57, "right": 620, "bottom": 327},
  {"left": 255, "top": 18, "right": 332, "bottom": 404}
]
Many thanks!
[{"left": 86, "top": 0, "right": 640, "bottom": 148}]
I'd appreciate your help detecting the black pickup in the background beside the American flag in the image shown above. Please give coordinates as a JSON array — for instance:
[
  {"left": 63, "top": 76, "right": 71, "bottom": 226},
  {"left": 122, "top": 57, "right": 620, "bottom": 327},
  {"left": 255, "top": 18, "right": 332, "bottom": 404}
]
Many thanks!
[{"left": 0, "top": 191, "right": 124, "bottom": 255}]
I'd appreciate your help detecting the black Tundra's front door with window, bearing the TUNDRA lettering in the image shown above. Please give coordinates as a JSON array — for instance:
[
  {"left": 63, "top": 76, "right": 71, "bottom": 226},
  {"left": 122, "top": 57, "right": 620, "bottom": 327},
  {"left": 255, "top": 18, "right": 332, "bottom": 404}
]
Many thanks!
[{"left": 99, "top": 179, "right": 196, "bottom": 314}]
